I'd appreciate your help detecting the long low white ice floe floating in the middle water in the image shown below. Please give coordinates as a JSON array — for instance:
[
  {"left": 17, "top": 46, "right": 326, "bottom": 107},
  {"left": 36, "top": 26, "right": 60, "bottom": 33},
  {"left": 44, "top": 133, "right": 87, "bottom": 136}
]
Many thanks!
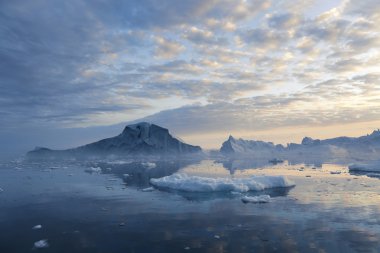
[{"left": 150, "top": 174, "right": 295, "bottom": 192}]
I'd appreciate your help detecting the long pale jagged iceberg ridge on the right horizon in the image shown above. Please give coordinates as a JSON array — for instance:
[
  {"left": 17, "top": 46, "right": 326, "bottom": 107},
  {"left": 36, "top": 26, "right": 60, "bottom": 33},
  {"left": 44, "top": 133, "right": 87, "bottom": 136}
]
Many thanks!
[{"left": 219, "top": 130, "right": 380, "bottom": 160}]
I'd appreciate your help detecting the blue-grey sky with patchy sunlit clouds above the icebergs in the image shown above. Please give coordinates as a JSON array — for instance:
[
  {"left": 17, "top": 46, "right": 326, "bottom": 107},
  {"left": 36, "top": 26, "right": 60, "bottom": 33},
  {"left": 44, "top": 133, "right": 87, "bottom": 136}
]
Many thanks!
[{"left": 0, "top": 0, "right": 380, "bottom": 153}]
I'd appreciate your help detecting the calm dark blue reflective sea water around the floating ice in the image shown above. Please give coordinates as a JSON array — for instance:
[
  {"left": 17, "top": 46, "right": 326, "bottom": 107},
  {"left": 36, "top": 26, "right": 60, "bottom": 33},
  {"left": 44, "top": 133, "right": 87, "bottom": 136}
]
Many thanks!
[{"left": 0, "top": 157, "right": 380, "bottom": 253}]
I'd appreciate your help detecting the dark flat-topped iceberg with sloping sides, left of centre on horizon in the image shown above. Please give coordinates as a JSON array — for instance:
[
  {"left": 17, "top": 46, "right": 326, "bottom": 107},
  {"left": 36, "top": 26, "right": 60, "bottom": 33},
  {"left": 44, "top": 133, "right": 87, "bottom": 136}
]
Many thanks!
[{"left": 28, "top": 122, "right": 202, "bottom": 157}]
